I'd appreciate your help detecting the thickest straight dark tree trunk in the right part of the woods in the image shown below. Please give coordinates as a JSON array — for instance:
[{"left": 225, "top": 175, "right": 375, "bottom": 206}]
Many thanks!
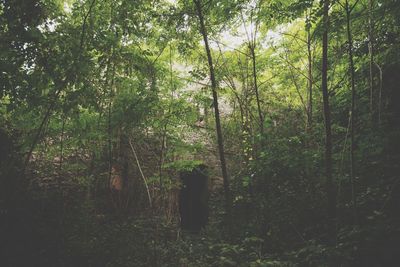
[{"left": 321, "top": 0, "right": 336, "bottom": 244}]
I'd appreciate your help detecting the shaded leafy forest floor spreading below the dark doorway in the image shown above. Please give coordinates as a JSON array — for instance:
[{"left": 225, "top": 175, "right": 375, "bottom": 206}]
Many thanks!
[{"left": 1, "top": 164, "right": 399, "bottom": 266}]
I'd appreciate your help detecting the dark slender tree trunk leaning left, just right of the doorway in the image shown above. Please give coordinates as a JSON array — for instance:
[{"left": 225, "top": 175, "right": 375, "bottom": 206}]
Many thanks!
[{"left": 194, "top": 0, "right": 232, "bottom": 216}]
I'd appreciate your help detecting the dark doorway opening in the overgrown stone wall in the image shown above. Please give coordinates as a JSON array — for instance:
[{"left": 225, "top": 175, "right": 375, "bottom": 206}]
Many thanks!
[{"left": 179, "top": 164, "right": 208, "bottom": 232}]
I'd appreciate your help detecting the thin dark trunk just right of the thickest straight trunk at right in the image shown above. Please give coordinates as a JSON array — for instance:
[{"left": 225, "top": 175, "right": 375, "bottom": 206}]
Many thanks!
[{"left": 346, "top": 0, "right": 357, "bottom": 224}]
